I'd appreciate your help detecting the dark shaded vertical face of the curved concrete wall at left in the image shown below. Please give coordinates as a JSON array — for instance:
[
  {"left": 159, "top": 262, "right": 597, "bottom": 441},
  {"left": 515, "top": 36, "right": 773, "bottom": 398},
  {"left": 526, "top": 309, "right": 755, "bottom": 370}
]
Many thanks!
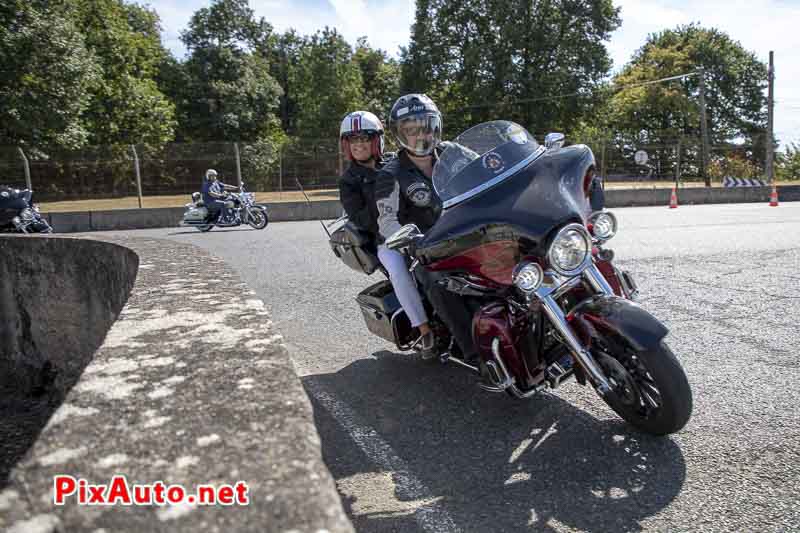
[{"left": 0, "top": 236, "right": 139, "bottom": 395}]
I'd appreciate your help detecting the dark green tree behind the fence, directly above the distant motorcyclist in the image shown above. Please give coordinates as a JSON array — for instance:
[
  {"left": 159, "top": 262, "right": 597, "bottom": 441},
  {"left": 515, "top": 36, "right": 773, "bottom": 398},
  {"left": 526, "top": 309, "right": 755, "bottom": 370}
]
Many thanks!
[{"left": 173, "top": 0, "right": 281, "bottom": 141}]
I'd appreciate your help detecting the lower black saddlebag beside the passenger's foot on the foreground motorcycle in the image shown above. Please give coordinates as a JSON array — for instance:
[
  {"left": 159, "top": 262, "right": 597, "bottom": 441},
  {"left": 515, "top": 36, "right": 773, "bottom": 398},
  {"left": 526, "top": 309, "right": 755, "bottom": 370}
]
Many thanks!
[{"left": 356, "top": 280, "right": 415, "bottom": 350}]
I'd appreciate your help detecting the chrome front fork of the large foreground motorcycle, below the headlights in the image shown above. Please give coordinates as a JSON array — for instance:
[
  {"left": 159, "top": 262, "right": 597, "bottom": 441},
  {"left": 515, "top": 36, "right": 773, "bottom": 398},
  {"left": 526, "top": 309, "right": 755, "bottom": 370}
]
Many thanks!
[{"left": 536, "top": 264, "right": 614, "bottom": 396}]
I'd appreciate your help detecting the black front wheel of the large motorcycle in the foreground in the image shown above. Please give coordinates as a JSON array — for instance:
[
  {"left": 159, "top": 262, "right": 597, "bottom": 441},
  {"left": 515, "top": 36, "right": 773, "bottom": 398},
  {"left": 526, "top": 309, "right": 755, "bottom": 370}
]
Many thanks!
[{"left": 594, "top": 342, "right": 692, "bottom": 435}]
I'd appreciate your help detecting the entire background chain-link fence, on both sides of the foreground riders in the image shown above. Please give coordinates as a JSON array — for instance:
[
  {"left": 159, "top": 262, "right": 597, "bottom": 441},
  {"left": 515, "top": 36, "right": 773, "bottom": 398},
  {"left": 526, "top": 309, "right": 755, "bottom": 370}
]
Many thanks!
[{"left": 0, "top": 134, "right": 776, "bottom": 202}]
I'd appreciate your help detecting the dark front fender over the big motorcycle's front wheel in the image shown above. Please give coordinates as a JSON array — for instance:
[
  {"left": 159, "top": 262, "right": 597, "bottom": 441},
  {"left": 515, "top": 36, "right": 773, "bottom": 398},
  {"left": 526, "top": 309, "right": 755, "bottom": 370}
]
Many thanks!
[{"left": 567, "top": 294, "right": 669, "bottom": 351}]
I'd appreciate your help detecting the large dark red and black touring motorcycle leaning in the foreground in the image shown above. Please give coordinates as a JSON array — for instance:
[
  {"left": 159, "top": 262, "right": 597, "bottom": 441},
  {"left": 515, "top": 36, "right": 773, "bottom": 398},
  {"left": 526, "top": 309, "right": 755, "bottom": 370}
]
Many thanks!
[{"left": 330, "top": 121, "right": 692, "bottom": 435}]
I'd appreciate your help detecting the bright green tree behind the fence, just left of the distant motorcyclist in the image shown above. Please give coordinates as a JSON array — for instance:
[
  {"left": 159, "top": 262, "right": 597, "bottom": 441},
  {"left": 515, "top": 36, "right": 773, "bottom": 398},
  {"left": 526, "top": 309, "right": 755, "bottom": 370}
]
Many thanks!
[{"left": 72, "top": 0, "right": 175, "bottom": 144}]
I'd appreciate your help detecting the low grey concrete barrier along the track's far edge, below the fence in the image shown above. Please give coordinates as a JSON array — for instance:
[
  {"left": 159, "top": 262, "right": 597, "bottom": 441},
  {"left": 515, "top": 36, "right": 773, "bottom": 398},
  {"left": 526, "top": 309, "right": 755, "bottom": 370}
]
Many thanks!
[{"left": 40, "top": 185, "right": 800, "bottom": 233}]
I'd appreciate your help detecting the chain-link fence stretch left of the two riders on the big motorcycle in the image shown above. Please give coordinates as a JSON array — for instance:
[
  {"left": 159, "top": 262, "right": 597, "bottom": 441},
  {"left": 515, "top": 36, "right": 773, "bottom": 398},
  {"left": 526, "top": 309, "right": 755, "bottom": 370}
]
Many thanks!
[{"left": 0, "top": 141, "right": 342, "bottom": 202}]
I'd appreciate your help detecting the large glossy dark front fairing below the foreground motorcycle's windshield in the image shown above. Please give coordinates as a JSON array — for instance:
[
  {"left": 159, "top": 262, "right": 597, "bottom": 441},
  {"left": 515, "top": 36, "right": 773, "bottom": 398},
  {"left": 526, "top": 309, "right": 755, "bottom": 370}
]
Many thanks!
[{"left": 417, "top": 145, "right": 594, "bottom": 276}]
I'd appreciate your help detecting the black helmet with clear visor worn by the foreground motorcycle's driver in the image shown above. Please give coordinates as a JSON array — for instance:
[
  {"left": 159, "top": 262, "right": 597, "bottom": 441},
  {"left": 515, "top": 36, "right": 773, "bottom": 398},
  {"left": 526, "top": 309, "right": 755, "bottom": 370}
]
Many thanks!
[{"left": 389, "top": 93, "right": 442, "bottom": 156}]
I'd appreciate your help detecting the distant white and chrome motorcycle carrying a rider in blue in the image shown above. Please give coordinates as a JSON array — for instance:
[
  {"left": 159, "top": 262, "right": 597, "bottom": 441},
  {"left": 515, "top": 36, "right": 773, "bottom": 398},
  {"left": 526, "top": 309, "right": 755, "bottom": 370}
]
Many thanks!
[{"left": 180, "top": 183, "right": 269, "bottom": 232}]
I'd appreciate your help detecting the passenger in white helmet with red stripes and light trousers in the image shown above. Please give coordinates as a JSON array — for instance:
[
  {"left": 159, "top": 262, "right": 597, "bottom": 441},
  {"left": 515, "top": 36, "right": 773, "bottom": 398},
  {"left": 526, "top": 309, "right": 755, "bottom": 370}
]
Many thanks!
[{"left": 339, "top": 111, "right": 433, "bottom": 352}]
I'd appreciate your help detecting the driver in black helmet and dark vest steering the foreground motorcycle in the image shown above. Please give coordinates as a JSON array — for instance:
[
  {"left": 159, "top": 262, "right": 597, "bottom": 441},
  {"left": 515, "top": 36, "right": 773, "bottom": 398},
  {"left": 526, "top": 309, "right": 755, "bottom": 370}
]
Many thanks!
[{"left": 375, "top": 93, "right": 477, "bottom": 362}]
